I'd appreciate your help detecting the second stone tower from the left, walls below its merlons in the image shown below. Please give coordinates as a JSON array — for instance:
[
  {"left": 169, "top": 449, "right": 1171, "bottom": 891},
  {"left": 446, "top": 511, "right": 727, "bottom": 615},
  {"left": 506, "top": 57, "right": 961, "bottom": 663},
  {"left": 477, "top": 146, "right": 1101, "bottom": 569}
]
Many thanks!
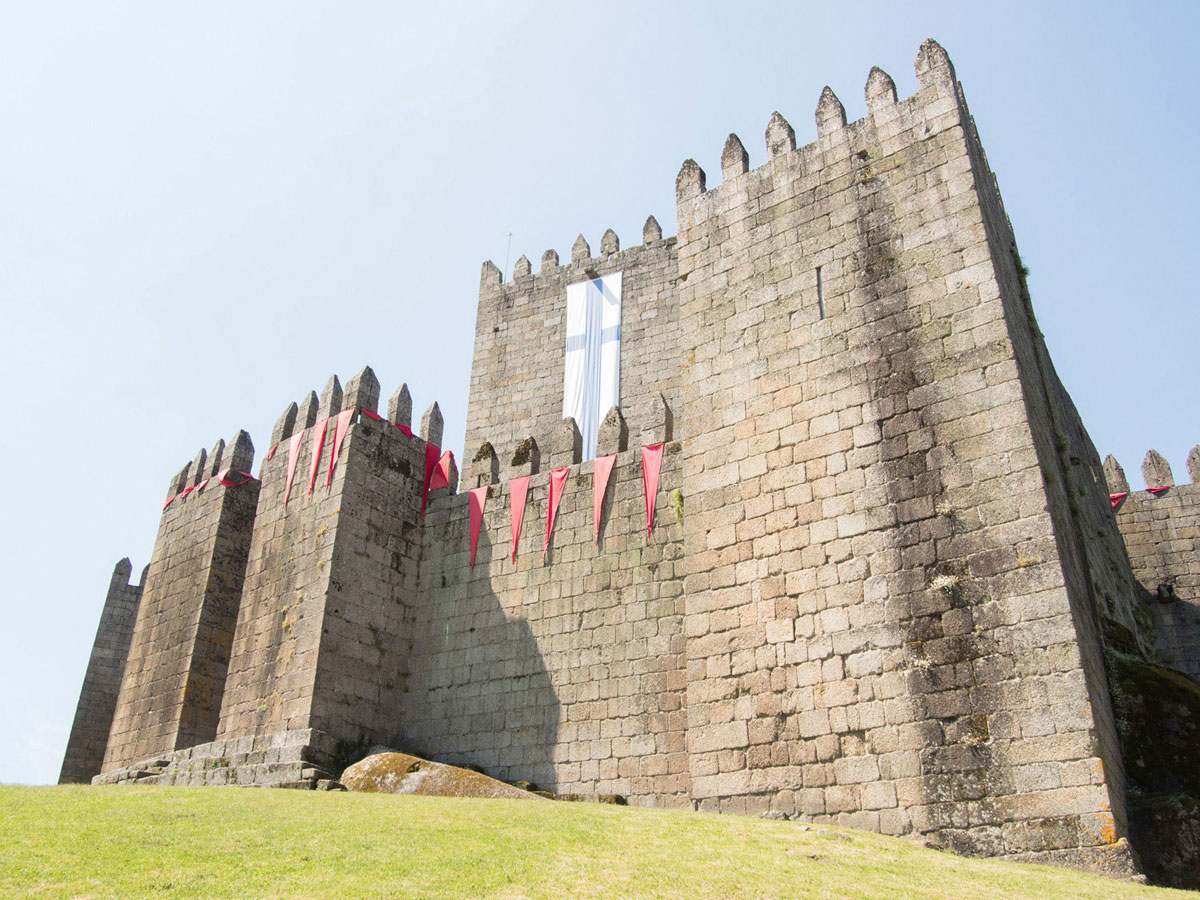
[{"left": 103, "top": 479, "right": 258, "bottom": 770}]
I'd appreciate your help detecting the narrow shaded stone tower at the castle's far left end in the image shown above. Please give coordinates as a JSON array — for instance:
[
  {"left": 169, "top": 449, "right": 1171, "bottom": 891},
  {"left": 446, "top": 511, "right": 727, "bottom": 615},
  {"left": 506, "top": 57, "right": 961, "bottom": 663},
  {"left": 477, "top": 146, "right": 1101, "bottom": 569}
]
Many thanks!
[{"left": 59, "top": 560, "right": 142, "bottom": 785}]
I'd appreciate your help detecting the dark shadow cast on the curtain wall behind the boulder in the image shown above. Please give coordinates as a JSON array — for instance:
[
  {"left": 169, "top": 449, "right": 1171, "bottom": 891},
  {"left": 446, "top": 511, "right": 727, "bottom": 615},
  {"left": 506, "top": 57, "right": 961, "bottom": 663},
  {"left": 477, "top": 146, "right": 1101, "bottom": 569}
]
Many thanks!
[{"left": 398, "top": 508, "right": 560, "bottom": 790}]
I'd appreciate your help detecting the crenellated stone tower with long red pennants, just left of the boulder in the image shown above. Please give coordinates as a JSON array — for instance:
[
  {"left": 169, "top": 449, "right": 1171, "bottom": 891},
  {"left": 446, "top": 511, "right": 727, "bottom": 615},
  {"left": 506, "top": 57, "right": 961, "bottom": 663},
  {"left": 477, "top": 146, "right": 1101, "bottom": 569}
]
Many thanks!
[{"left": 217, "top": 368, "right": 440, "bottom": 782}]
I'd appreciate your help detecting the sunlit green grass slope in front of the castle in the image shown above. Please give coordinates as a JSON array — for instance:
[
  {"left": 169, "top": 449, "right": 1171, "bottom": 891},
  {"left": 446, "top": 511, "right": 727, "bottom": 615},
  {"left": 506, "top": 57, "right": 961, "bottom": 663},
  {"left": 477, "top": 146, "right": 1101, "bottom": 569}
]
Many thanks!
[{"left": 0, "top": 786, "right": 1195, "bottom": 900}]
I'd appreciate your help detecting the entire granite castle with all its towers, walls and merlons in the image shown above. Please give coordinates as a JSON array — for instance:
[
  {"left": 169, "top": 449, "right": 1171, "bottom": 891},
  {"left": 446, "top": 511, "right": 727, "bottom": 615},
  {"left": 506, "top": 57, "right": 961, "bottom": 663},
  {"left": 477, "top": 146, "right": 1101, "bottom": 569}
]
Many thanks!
[{"left": 62, "top": 41, "right": 1200, "bottom": 883}]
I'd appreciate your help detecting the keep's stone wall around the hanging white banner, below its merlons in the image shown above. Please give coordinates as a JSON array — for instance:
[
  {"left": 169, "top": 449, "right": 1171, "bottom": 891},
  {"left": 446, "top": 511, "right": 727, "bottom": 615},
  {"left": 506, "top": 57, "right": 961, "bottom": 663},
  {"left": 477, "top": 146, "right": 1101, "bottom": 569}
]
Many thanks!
[{"left": 463, "top": 239, "right": 680, "bottom": 486}]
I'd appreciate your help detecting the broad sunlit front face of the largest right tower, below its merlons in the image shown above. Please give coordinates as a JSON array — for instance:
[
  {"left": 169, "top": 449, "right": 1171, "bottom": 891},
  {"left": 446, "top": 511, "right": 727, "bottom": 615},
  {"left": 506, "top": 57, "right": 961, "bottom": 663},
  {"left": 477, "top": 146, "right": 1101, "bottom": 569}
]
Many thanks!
[{"left": 678, "top": 80, "right": 1115, "bottom": 854}]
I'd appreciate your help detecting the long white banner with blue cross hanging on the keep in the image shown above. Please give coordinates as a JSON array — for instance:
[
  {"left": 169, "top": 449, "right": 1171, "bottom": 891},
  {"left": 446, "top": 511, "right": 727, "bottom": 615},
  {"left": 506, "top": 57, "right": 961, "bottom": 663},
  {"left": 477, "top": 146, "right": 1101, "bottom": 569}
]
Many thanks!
[{"left": 563, "top": 272, "right": 620, "bottom": 460}]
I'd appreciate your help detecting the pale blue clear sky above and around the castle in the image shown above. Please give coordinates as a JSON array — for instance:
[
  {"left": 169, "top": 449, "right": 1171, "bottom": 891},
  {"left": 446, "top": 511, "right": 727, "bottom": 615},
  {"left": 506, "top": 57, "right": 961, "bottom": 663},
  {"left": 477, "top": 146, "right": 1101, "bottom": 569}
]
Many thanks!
[{"left": 0, "top": 1, "right": 1200, "bottom": 782}]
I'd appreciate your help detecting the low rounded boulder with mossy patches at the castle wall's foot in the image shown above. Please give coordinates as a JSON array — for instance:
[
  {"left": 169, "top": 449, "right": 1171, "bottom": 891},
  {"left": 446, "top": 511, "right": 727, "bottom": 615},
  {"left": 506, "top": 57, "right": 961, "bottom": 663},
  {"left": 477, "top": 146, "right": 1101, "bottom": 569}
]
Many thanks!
[{"left": 341, "top": 752, "right": 542, "bottom": 800}]
